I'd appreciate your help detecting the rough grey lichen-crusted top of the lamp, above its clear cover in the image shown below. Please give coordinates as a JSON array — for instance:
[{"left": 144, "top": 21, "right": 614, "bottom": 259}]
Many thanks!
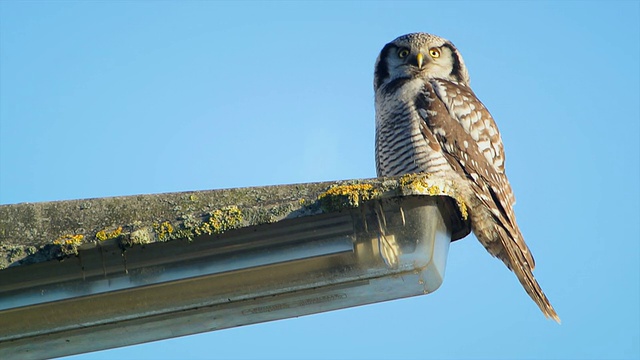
[{"left": 0, "top": 174, "right": 467, "bottom": 269}]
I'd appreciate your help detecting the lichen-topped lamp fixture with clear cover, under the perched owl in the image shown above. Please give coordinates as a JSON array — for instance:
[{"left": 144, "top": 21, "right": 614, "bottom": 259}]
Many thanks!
[{"left": 0, "top": 176, "right": 469, "bottom": 359}]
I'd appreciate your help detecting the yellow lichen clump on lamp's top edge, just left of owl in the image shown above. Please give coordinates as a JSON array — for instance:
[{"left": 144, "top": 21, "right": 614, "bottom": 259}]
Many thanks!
[{"left": 318, "top": 184, "right": 380, "bottom": 211}]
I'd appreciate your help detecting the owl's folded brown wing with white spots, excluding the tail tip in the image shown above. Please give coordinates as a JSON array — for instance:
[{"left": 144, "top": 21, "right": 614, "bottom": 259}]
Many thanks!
[{"left": 416, "top": 80, "right": 535, "bottom": 269}]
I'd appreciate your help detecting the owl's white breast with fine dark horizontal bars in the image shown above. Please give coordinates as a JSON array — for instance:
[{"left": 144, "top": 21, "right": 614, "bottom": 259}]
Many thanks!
[{"left": 376, "top": 79, "right": 450, "bottom": 180}]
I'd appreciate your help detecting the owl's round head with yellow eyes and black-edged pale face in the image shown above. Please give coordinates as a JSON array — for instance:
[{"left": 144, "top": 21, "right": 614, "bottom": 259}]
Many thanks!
[{"left": 373, "top": 33, "right": 469, "bottom": 91}]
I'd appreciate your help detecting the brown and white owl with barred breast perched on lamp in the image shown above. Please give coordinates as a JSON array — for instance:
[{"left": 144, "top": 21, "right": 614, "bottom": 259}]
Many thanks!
[{"left": 373, "top": 33, "right": 560, "bottom": 322}]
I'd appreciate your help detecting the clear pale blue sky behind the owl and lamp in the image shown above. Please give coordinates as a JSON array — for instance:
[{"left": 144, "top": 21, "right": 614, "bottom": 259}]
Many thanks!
[{"left": 0, "top": 1, "right": 640, "bottom": 359}]
